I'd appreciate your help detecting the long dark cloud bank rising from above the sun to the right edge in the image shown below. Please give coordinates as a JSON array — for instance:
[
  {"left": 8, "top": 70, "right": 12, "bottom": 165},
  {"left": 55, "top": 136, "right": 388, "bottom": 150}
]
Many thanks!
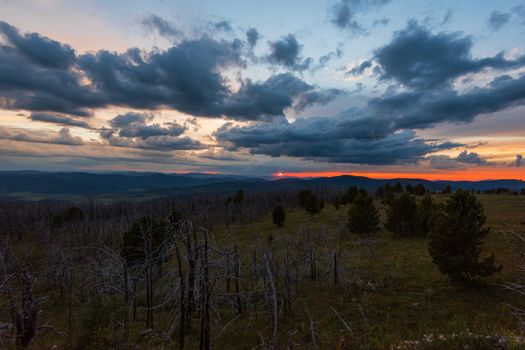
[{"left": 215, "top": 70, "right": 525, "bottom": 164}]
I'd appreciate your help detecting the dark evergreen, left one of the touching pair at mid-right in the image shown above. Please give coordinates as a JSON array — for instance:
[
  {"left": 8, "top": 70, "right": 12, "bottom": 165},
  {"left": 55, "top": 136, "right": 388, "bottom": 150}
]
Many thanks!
[{"left": 385, "top": 192, "right": 417, "bottom": 237}]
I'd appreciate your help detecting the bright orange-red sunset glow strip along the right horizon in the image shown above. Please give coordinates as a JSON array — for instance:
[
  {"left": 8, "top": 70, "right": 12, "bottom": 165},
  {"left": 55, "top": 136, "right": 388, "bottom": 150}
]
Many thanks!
[{"left": 272, "top": 168, "right": 525, "bottom": 181}]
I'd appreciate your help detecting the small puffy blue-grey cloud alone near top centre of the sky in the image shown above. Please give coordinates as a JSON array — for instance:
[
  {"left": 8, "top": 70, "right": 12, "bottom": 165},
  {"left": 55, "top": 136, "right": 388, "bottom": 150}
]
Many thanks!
[{"left": 267, "top": 34, "right": 312, "bottom": 71}]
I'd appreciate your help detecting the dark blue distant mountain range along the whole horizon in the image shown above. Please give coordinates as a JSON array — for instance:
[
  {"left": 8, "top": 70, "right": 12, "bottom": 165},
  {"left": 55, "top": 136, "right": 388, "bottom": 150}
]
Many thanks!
[{"left": 0, "top": 171, "right": 525, "bottom": 199}]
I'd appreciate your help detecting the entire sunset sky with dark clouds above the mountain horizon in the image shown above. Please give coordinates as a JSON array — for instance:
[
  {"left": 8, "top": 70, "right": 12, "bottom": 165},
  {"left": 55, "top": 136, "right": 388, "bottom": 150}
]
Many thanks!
[{"left": 0, "top": 0, "right": 525, "bottom": 180}]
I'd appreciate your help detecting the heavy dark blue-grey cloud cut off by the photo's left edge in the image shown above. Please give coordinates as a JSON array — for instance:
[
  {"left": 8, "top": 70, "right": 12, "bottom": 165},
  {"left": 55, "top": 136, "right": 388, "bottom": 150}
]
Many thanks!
[{"left": 0, "top": 22, "right": 102, "bottom": 116}]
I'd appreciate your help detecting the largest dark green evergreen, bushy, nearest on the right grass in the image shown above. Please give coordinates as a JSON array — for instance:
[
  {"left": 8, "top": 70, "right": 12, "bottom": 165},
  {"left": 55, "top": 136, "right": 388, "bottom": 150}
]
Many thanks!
[{"left": 428, "top": 190, "right": 501, "bottom": 282}]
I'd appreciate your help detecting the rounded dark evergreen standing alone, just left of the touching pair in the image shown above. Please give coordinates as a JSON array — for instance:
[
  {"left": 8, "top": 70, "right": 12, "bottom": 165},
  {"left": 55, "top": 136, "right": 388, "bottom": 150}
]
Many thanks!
[{"left": 348, "top": 192, "right": 379, "bottom": 235}]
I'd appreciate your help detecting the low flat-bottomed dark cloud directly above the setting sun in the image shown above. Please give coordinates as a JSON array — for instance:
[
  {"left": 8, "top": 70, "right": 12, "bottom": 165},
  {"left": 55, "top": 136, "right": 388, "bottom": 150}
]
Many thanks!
[{"left": 215, "top": 119, "right": 457, "bottom": 164}]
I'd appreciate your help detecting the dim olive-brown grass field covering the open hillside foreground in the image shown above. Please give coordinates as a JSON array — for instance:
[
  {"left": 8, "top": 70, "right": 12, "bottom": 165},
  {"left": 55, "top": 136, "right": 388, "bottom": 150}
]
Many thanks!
[{"left": 4, "top": 195, "right": 525, "bottom": 349}]
